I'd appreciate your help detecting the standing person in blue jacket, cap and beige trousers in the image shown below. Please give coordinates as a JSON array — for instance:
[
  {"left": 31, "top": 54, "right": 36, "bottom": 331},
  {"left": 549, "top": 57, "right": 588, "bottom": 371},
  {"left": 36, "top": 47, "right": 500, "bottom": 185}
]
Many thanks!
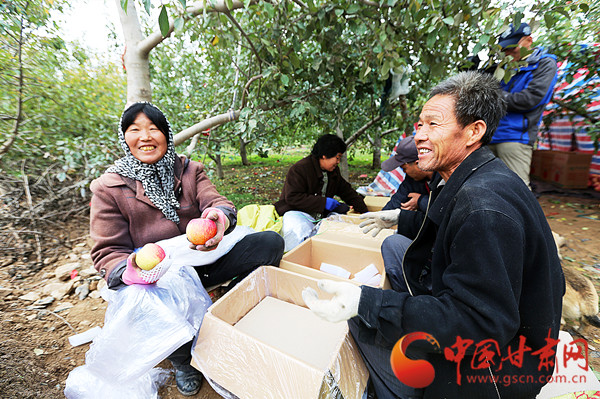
[{"left": 489, "top": 23, "right": 557, "bottom": 186}]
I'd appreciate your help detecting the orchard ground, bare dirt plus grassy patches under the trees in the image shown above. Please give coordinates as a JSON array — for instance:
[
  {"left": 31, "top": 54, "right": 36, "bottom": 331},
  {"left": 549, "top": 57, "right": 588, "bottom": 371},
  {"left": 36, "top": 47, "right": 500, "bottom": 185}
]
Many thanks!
[{"left": 0, "top": 152, "right": 600, "bottom": 399}]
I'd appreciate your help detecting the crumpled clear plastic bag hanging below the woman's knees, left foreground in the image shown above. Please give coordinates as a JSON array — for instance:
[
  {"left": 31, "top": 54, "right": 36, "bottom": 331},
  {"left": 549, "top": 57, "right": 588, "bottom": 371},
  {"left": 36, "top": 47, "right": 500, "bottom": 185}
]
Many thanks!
[{"left": 64, "top": 264, "right": 212, "bottom": 399}]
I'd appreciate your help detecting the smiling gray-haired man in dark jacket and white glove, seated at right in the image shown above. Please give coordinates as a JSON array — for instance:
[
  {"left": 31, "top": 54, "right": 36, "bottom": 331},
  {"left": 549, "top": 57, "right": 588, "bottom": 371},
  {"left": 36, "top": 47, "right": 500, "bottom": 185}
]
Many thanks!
[{"left": 303, "top": 72, "right": 564, "bottom": 399}]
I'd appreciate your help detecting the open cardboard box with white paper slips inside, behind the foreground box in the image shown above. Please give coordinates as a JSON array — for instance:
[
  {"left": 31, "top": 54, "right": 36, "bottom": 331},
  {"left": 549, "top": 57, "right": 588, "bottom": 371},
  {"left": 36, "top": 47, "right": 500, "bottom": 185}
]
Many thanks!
[{"left": 279, "top": 236, "right": 391, "bottom": 289}]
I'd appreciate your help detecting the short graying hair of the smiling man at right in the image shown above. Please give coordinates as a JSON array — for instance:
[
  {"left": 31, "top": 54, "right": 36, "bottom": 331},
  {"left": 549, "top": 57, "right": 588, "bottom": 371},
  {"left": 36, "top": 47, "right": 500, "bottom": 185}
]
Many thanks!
[{"left": 429, "top": 71, "right": 506, "bottom": 145}]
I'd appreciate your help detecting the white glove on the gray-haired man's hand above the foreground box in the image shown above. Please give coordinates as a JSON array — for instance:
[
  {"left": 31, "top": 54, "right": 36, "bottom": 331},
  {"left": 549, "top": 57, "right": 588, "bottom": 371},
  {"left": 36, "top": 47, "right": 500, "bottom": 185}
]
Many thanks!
[{"left": 302, "top": 280, "right": 361, "bottom": 323}]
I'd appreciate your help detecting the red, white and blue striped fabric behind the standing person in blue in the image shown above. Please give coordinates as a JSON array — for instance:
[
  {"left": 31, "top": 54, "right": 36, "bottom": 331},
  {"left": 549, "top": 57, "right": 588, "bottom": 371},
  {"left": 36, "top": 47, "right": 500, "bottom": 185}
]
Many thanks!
[{"left": 538, "top": 49, "right": 600, "bottom": 174}]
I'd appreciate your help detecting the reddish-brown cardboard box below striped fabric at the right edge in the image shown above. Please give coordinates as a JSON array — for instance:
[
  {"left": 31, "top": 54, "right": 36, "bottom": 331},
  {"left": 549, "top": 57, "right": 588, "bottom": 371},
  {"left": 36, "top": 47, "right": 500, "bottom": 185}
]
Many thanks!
[{"left": 547, "top": 151, "right": 592, "bottom": 188}]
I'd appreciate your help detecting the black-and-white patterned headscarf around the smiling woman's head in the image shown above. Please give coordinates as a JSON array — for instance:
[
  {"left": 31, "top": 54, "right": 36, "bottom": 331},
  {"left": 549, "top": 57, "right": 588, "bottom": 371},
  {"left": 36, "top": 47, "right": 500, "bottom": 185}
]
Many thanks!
[{"left": 106, "top": 102, "right": 179, "bottom": 224}]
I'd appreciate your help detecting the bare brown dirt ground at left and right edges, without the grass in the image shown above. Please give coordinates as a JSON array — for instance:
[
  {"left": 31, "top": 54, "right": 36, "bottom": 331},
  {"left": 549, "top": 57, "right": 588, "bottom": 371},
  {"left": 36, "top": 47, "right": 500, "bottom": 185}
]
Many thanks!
[{"left": 0, "top": 182, "right": 600, "bottom": 399}]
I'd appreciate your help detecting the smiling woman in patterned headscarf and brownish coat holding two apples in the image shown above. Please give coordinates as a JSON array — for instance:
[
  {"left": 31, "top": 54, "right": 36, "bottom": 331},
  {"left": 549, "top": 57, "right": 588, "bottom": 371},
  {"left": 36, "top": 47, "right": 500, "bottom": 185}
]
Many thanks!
[{"left": 90, "top": 102, "right": 284, "bottom": 395}]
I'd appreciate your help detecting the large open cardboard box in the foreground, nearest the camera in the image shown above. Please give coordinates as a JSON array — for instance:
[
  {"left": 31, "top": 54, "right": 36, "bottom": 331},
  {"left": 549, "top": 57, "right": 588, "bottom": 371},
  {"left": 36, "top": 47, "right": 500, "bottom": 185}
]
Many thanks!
[{"left": 192, "top": 266, "right": 368, "bottom": 399}]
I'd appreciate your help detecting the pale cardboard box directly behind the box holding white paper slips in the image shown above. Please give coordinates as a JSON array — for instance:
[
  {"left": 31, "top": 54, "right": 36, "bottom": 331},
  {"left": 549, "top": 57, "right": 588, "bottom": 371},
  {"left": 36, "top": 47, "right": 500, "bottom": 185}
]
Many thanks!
[{"left": 314, "top": 215, "right": 396, "bottom": 250}]
